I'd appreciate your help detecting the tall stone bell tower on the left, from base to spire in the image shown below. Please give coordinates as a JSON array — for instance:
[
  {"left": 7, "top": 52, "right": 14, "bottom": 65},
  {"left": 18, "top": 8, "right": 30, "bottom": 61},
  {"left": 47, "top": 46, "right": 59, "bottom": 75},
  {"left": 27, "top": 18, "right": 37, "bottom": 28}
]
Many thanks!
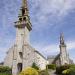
[{"left": 12, "top": 0, "right": 32, "bottom": 75}]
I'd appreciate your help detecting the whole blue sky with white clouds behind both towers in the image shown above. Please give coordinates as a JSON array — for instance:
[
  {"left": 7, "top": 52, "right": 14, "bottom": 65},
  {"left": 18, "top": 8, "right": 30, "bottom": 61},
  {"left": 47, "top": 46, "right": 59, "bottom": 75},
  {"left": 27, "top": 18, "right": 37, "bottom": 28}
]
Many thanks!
[{"left": 0, "top": 0, "right": 75, "bottom": 62}]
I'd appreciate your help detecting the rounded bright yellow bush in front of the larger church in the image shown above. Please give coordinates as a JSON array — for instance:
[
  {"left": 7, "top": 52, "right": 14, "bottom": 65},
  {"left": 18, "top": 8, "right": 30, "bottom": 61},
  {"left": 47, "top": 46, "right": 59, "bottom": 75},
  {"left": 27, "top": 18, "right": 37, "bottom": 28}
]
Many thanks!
[{"left": 19, "top": 68, "right": 38, "bottom": 75}]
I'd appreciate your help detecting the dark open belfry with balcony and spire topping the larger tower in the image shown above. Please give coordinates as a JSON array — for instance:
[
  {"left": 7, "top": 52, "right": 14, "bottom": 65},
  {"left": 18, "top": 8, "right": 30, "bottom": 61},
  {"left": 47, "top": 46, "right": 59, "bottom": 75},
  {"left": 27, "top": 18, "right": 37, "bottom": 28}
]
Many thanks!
[{"left": 15, "top": 0, "right": 32, "bottom": 31}]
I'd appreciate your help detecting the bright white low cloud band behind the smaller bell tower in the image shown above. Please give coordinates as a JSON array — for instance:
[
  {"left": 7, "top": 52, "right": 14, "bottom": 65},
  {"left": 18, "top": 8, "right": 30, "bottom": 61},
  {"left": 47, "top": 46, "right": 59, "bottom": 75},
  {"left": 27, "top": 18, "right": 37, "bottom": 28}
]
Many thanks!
[{"left": 34, "top": 41, "right": 75, "bottom": 55}]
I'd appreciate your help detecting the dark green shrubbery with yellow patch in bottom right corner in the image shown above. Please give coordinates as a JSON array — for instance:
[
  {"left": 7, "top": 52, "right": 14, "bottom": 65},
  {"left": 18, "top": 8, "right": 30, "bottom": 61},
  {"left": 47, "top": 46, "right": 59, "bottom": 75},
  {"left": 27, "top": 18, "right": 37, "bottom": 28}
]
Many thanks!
[{"left": 56, "top": 65, "right": 75, "bottom": 75}]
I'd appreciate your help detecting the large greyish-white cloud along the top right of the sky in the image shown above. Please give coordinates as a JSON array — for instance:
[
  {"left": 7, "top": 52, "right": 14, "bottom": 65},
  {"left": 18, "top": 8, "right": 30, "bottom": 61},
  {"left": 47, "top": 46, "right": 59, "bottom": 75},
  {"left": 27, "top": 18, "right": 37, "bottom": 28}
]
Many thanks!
[{"left": 32, "top": 0, "right": 75, "bottom": 15}]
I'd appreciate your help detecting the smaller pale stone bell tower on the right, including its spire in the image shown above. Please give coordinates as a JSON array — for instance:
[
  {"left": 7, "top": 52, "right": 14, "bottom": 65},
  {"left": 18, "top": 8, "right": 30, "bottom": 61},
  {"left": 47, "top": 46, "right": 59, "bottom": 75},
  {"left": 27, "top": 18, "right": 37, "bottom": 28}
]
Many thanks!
[{"left": 59, "top": 33, "right": 69, "bottom": 65}]
